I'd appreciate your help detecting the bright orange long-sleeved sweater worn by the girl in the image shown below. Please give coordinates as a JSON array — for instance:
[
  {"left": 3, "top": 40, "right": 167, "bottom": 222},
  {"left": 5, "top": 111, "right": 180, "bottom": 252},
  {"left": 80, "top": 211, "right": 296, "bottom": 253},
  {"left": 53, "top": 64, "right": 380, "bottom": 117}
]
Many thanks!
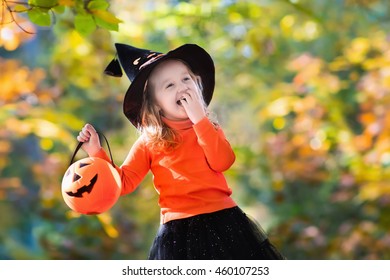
[{"left": 95, "top": 117, "right": 236, "bottom": 223}]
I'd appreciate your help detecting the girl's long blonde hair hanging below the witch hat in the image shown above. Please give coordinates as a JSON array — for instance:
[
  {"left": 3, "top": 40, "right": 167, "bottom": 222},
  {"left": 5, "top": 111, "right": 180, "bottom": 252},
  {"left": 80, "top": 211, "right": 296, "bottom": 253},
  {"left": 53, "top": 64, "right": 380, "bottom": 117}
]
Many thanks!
[{"left": 138, "top": 60, "right": 217, "bottom": 152}]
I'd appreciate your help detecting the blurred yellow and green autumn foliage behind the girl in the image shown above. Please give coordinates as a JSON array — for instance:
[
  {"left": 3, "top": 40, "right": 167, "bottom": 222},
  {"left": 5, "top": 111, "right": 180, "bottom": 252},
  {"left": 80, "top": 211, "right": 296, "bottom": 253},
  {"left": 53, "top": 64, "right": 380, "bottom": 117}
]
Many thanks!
[{"left": 0, "top": 0, "right": 390, "bottom": 259}]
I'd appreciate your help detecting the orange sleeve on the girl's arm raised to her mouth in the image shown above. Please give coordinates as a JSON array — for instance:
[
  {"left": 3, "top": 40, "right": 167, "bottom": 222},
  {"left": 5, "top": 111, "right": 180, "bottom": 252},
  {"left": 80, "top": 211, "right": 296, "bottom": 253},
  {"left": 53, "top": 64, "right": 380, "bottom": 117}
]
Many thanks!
[{"left": 194, "top": 117, "right": 236, "bottom": 172}]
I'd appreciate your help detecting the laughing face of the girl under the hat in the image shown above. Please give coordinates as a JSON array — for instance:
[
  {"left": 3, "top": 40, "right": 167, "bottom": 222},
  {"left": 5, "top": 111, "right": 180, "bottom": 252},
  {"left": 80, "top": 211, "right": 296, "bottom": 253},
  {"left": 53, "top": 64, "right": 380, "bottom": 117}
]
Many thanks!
[{"left": 149, "top": 60, "right": 200, "bottom": 121}]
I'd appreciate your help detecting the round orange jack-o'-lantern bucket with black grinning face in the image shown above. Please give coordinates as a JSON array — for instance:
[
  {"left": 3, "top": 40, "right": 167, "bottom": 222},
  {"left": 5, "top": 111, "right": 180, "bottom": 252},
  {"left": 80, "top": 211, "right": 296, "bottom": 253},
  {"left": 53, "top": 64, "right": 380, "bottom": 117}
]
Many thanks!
[{"left": 61, "top": 157, "right": 121, "bottom": 215}]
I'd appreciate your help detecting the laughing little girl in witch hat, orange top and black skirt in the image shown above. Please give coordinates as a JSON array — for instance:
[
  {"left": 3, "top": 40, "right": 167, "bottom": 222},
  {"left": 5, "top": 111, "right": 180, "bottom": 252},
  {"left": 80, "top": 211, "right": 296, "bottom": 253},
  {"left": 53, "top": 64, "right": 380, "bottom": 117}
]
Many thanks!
[{"left": 77, "top": 44, "right": 284, "bottom": 259}]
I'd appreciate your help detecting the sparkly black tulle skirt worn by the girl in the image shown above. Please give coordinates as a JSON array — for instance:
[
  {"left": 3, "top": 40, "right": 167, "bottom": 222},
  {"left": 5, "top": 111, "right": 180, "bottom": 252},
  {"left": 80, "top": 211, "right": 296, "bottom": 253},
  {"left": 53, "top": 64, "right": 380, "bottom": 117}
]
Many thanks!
[{"left": 149, "top": 207, "right": 285, "bottom": 260}]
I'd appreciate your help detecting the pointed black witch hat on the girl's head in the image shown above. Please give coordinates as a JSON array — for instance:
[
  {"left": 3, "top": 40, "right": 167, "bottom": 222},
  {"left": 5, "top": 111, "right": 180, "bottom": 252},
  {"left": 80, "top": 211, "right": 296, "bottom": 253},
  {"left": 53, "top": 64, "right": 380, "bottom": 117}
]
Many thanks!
[{"left": 104, "top": 43, "right": 215, "bottom": 127}]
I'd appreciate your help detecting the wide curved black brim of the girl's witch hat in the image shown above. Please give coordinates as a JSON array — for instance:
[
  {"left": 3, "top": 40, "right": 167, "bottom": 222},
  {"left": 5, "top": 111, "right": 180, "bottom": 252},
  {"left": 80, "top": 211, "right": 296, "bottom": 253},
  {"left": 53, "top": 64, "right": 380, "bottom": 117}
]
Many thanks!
[{"left": 123, "top": 44, "right": 215, "bottom": 127}]
